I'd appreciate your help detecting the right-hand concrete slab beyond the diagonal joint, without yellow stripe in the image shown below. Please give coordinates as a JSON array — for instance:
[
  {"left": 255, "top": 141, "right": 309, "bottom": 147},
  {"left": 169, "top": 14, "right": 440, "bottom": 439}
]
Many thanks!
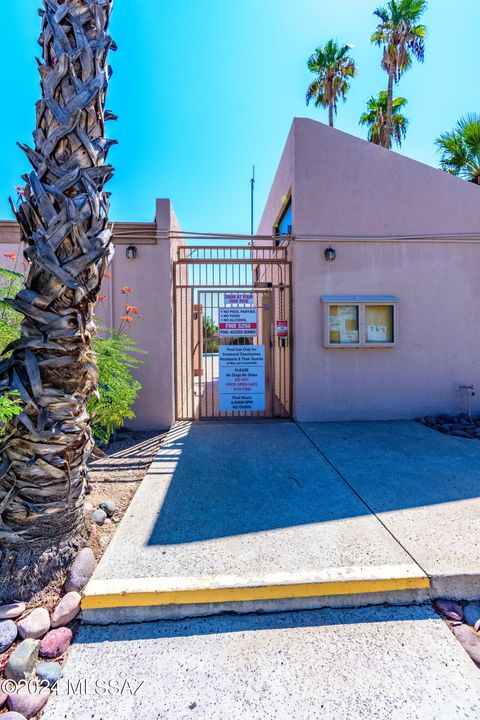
[{"left": 301, "top": 422, "right": 480, "bottom": 599}]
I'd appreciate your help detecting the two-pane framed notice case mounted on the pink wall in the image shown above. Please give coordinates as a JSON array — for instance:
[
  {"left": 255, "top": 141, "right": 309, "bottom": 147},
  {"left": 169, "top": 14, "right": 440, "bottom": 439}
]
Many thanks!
[{"left": 322, "top": 295, "right": 398, "bottom": 348}]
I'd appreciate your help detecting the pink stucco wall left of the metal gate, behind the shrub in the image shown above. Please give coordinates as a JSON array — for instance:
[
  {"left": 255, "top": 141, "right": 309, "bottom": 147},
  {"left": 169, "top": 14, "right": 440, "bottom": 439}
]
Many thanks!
[{"left": 0, "top": 199, "right": 179, "bottom": 429}]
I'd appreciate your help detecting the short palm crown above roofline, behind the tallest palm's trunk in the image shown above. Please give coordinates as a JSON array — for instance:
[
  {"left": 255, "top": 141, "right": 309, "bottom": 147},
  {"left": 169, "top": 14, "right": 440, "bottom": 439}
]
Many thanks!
[{"left": 360, "top": 90, "right": 408, "bottom": 148}]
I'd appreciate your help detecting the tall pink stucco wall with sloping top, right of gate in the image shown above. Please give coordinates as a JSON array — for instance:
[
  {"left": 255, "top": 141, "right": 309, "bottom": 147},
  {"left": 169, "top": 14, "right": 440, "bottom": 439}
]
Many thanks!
[{"left": 259, "top": 119, "right": 480, "bottom": 420}]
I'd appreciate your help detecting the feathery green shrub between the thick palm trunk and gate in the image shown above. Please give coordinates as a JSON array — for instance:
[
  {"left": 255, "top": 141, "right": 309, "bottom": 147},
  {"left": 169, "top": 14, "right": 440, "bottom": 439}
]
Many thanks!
[{"left": 88, "top": 330, "right": 146, "bottom": 443}]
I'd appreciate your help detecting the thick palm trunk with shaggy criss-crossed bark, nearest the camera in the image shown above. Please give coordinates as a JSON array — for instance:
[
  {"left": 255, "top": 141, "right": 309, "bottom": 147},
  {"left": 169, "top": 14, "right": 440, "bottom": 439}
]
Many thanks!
[{"left": 0, "top": 0, "right": 115, "bottom": 600}]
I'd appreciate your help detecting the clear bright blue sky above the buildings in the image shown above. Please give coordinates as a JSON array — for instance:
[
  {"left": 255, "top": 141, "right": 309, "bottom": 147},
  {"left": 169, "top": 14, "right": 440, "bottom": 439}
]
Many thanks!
[{"left": 0, "top": 0, "right": 480, "bottom": 233}]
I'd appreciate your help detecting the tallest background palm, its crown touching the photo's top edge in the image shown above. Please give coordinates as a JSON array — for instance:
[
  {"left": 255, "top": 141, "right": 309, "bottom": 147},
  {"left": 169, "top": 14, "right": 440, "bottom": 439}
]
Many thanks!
[{"left": 371, "top": 0, "right": 427, "bottom": 147}]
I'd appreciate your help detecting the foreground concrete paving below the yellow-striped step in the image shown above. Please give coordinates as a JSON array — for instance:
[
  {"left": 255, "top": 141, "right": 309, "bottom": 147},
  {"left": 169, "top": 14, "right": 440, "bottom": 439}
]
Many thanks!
[{"left": 43, "top": 606, "right": 480, "bottom": 720}]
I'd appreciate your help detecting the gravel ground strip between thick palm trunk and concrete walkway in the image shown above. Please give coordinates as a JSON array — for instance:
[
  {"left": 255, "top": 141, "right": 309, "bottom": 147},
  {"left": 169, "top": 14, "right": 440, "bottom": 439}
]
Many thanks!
[{"left": 86, "top": 430, "right": 164, "bottom": 560}]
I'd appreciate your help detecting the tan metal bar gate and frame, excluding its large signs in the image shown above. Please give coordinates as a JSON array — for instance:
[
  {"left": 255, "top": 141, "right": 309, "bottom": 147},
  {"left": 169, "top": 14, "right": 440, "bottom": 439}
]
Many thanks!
[{"left": 173, "top": 244, "right": 292, "bottom": 420}]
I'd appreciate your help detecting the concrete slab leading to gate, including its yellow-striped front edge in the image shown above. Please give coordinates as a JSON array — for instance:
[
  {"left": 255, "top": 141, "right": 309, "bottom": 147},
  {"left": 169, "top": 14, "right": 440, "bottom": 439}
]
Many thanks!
[{"left": 83, "top": 422, "right": 429, "bottom": 622}]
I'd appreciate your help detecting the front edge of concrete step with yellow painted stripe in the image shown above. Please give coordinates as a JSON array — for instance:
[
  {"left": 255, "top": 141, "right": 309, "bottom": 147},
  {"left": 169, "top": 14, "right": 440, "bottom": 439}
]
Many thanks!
[{"left": 82, "top": 565, "right": 430, "bottom": 624}]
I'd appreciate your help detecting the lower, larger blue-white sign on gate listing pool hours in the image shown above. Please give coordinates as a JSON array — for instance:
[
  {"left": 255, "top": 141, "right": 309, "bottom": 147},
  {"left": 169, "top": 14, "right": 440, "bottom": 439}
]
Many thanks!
[{"left": 218, "top": 345, "right": 265, "bottom": 412}]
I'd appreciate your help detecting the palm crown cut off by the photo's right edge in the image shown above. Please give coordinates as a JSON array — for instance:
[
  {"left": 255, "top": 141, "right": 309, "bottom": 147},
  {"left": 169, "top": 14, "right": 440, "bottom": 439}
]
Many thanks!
[{"left": 435, "top": 113, "right": 480, "bottom": 185}]
